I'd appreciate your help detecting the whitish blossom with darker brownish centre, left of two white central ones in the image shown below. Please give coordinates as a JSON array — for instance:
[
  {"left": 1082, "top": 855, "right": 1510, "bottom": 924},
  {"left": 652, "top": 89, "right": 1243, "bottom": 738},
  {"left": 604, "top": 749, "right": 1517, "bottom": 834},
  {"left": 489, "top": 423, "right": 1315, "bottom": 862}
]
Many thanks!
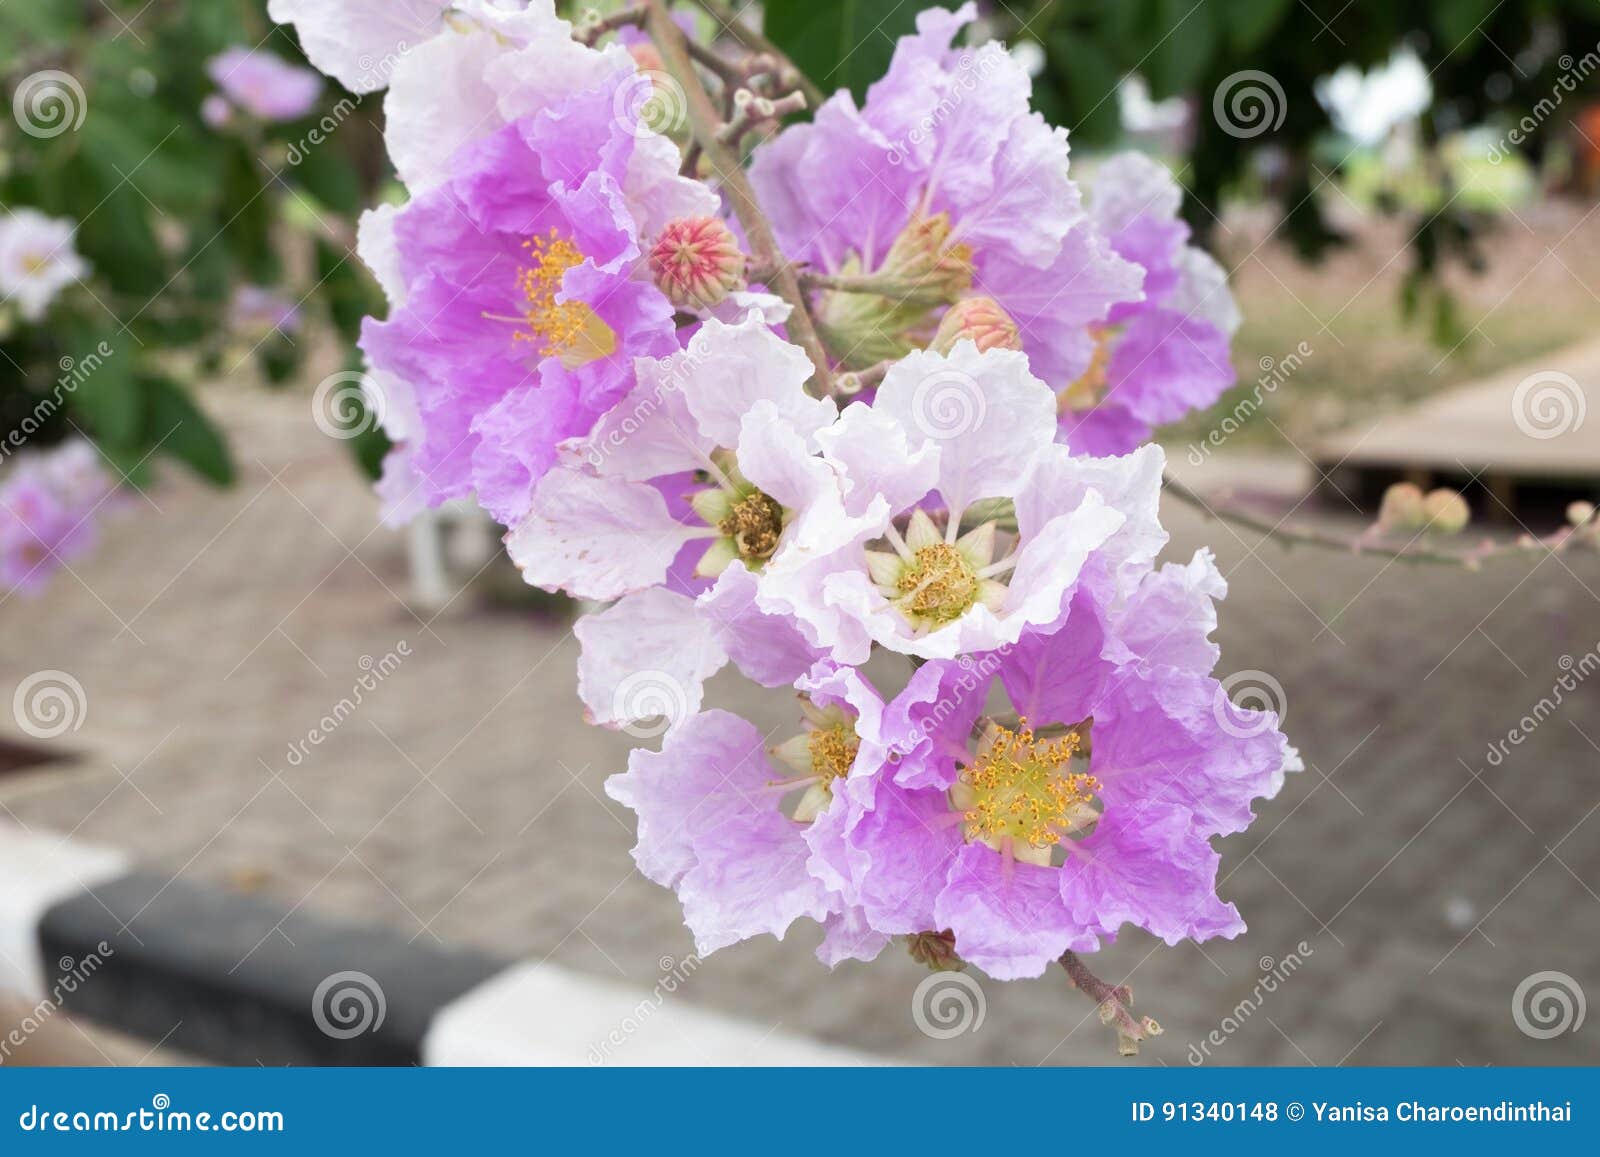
[{"left": 506, "top": 312, "right": 844, "bottom": 727}]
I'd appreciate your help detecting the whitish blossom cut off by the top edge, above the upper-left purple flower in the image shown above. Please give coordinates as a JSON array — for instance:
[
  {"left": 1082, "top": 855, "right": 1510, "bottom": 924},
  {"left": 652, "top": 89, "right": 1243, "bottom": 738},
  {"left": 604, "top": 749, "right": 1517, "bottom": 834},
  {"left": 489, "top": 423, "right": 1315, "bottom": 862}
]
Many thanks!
[{"left": 267, "top": 0, "right": 630, "bottom": 192}]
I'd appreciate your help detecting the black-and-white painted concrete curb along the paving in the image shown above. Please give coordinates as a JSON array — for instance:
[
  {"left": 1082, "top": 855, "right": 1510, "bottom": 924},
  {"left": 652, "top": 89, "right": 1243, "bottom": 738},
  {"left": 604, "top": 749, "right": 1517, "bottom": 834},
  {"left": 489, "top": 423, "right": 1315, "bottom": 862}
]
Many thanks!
[{"left": 0, "top": 824, "right": 878, "bottom": 1066}]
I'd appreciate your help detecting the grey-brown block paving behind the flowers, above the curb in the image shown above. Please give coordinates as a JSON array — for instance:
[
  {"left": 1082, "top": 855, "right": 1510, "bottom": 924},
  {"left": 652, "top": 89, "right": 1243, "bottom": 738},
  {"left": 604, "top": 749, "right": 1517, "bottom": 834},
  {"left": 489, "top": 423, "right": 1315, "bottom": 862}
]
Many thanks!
[{"left": 0, "top": 388, "right": 1600, "bottom": 1066}]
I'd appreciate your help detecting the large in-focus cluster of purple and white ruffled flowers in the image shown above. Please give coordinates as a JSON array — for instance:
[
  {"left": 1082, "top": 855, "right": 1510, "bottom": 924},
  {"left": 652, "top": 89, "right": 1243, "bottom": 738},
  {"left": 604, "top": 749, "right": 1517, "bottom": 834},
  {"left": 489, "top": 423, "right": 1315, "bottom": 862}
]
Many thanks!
[{"left": 272, "top": 0, "right": 1298, "bottom": 1024}]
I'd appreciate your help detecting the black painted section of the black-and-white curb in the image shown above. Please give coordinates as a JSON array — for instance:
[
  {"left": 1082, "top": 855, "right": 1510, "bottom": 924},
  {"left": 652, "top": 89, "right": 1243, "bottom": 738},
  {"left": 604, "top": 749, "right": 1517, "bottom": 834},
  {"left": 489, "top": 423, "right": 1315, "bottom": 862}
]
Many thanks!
[{"left": 38, "top": 872, "right": 507, "bottom": 1064}]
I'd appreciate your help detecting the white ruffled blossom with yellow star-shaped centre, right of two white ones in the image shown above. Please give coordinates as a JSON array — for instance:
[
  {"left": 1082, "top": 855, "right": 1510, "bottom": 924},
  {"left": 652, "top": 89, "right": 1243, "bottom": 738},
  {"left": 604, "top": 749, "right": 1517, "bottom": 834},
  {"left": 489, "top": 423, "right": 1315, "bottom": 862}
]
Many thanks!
[{"left": 757, "top": 341, "right": 1165, "bottom": 664}]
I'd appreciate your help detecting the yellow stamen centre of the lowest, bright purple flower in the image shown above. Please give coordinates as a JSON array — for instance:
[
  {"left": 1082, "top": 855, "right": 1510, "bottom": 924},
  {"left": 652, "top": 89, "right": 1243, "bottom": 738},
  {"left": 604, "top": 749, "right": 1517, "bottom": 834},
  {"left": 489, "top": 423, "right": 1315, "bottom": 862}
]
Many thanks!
[{"left": 957, "top": 719, "right": 1101, "bottom": 850}]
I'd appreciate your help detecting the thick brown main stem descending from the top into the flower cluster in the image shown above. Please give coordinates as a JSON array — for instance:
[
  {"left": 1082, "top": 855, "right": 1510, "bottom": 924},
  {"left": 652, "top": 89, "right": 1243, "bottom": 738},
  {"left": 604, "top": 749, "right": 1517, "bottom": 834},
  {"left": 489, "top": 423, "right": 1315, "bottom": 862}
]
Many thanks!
[{"left": 645, "top": 0, "right": 834, "bottom": 395}]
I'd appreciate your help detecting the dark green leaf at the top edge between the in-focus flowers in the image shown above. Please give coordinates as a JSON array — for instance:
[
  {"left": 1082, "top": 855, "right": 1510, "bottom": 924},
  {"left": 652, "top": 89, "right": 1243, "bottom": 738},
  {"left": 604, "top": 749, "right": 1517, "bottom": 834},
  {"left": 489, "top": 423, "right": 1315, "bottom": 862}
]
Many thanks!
[{"left": 765, "top": 0, "right": 955, "bottom": 101}]
